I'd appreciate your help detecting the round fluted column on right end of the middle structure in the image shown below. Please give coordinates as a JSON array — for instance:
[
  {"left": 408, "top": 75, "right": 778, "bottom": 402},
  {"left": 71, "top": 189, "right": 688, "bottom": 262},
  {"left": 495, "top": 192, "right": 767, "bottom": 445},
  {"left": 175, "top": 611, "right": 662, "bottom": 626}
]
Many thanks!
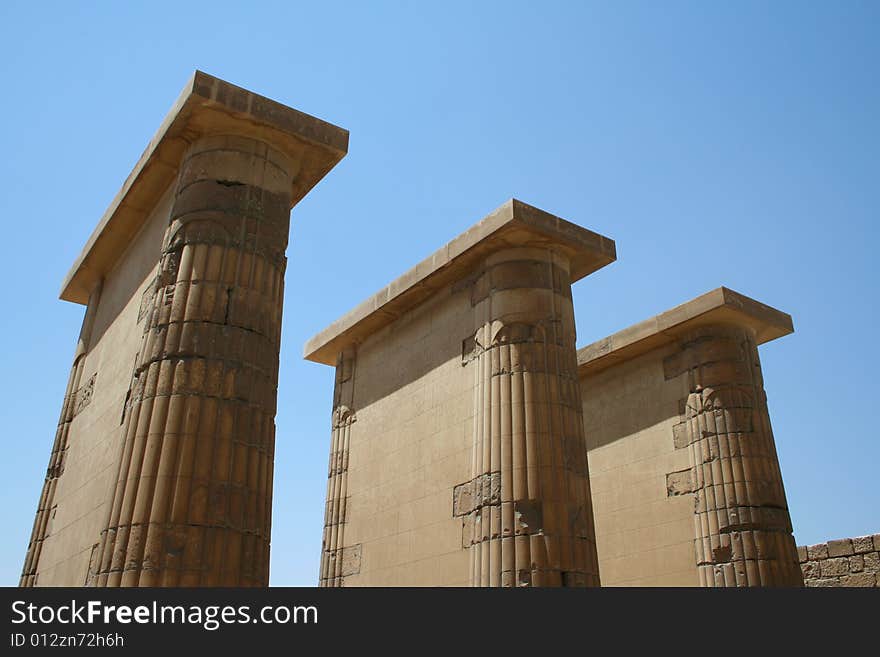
[{"left": 455, "top": 248, "right": 599, "bottom": 586}]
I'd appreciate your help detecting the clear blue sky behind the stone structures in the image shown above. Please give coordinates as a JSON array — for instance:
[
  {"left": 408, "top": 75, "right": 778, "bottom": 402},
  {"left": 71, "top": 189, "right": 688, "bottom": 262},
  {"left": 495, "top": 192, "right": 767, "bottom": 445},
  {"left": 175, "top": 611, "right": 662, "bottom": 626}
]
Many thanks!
[{"left": 0, "top": 0, "right": 880, "bottom": 585}]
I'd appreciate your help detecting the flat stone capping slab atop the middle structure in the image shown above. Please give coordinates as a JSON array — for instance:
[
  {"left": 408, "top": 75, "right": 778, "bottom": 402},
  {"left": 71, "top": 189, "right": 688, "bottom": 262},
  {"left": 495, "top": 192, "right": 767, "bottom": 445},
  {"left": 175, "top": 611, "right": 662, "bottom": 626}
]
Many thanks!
[{"left": 303, "top": 199, "right": 617, "bottom": 365}]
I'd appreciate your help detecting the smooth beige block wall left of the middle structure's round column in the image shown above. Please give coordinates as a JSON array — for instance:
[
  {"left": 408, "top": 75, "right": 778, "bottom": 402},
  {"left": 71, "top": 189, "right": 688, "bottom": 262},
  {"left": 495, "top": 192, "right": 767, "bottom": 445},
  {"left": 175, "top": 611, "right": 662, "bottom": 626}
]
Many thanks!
[{"left": 320, "top": 282, "right": 474, "bottom": 586}]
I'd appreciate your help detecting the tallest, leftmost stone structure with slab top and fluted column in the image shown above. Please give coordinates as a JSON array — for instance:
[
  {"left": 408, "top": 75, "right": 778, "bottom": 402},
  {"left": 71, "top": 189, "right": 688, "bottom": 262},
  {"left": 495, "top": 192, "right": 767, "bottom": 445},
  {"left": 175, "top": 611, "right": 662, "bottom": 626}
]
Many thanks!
[{"left": 21, "top": 72, "right": 348, "bottom": 586}]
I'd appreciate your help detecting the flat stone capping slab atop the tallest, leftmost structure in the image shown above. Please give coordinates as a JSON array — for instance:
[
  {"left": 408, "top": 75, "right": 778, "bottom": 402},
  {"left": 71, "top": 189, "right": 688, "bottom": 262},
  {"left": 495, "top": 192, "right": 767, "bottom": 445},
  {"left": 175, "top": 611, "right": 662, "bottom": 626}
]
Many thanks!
[{"left": 60, "top": 71, "right": 348, "bottom": 304}]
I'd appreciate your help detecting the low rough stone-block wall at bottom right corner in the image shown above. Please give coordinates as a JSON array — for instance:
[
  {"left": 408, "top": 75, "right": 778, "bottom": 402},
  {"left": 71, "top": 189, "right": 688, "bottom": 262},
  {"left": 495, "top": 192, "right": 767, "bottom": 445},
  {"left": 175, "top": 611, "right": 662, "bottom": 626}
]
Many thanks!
[{"left": 798, "top": 534, "right": 880, "bottom": 587}]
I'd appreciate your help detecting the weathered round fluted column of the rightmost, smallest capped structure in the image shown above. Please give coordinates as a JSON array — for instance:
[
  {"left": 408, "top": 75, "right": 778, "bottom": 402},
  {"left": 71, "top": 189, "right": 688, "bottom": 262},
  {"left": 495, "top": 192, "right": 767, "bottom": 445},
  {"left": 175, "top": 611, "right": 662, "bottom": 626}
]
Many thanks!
[{"left": 667, "top": 325, "right": 803, "bottom": 586}]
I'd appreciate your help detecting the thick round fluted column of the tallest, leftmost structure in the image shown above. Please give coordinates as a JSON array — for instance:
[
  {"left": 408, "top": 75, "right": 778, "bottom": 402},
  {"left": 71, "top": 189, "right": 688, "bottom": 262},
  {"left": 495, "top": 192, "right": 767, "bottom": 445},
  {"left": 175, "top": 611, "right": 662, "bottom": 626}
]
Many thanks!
[{"left": 93, "top": 135, "right": 297, "bottom": 586}]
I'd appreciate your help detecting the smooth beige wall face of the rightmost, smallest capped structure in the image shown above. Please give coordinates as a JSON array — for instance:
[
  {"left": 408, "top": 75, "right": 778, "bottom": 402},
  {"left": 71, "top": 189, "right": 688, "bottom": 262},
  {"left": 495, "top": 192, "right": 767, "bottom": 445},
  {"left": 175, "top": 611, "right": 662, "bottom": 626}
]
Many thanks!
[{"left": 581, "top": 338, "right": 700, "bottom": 586}]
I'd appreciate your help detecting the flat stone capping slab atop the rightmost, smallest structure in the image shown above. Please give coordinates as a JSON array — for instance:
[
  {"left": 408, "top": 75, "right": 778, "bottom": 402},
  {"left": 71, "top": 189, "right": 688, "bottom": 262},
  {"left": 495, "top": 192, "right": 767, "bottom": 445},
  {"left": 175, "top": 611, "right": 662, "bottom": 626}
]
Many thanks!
[{"left": 577, "top": 287, "right": 794, "bottom": 377}]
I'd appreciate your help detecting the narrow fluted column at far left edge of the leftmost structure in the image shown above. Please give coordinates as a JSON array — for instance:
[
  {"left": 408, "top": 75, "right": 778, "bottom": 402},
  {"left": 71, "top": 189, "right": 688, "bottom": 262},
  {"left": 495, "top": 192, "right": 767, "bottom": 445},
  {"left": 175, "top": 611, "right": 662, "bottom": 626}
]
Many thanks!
[{"left": 18, "top": 281, "right": 102, "bottom": 586}]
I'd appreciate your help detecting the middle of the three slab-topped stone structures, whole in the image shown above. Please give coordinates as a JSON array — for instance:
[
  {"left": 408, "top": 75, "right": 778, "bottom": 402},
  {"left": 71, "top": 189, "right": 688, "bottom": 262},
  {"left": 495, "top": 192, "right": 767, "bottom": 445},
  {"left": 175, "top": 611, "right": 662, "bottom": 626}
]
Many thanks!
[{"left": 305, "top": 201, "right": 615, "bottom": 586}]
